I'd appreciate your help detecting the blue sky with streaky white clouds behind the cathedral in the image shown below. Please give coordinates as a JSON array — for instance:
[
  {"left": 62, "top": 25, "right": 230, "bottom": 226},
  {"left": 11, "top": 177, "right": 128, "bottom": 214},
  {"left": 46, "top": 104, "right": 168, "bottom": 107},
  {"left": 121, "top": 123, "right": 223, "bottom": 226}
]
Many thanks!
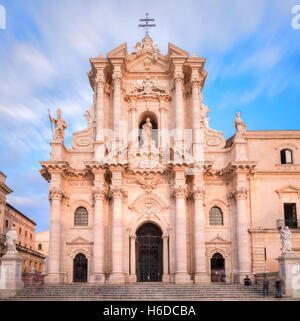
[{"left": 0, "top": 0, "right": 300, "bottom": 232}]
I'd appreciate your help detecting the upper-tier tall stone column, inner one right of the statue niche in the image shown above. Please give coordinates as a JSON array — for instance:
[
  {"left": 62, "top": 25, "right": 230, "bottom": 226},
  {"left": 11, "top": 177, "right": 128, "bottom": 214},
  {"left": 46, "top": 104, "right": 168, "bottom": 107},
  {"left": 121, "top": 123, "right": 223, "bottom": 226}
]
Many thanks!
[{"left": 174, "top": 65, "right": 184, "bottom": 162}]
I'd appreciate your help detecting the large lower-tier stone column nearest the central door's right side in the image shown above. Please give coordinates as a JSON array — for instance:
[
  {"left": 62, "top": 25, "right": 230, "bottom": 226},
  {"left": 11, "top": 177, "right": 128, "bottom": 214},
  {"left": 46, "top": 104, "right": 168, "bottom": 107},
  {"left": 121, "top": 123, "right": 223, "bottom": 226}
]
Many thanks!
[{"left": 174, "top": 185, "right": 191, "bottom": 284}]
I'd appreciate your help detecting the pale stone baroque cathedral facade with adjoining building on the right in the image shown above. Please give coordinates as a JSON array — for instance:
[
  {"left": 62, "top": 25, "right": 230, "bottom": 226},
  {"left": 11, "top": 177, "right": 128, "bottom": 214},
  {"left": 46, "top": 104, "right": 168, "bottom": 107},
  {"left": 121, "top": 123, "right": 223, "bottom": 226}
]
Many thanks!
[{"left": 40, "top": 36, "right": 300, "bottom": 284}]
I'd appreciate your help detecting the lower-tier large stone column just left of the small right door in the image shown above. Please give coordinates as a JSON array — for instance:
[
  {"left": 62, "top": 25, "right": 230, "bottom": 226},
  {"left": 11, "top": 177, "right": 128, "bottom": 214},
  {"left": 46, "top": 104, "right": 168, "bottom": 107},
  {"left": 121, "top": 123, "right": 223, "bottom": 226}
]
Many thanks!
[{"left": 193, "top": 186, "right": 209, "bottom": 284}]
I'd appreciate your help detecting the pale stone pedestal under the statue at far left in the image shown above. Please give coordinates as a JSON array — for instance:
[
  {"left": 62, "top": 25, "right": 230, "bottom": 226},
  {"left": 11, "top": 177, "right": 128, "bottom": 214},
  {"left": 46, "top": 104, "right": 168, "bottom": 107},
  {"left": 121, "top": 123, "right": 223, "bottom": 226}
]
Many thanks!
[{"left": 0, "top": 254, "right": 24, "bottom": 298}]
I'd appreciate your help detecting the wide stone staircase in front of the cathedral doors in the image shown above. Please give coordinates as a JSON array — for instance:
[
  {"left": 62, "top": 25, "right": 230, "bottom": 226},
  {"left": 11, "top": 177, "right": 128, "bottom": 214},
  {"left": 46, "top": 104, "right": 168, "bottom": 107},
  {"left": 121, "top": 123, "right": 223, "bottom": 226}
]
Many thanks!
[{"left": 10, "top": 283, "right": 287, "bottom": 301}]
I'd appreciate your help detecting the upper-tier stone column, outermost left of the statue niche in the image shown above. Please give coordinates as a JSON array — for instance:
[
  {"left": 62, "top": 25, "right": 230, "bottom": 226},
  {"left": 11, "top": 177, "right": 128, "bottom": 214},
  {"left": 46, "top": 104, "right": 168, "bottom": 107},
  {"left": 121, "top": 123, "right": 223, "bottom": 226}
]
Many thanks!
[{"left": 94, "top": 70, "right": 105, "bottom": 161}]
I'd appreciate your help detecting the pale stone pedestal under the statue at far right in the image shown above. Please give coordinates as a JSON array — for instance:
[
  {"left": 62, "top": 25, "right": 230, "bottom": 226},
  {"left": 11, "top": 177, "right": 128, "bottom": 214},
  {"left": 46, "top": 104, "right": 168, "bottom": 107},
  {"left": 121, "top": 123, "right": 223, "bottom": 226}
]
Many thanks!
[{"left": 276, "top": 253, "right": 300, "bottom": 298}]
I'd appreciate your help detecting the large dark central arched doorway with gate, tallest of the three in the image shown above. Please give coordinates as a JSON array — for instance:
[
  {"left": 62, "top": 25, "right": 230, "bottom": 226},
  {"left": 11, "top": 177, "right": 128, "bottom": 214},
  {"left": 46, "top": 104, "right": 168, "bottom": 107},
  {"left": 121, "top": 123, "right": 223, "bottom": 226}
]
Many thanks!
[{"left": 136, "top": 223, "right": 162, "bottom": 282}]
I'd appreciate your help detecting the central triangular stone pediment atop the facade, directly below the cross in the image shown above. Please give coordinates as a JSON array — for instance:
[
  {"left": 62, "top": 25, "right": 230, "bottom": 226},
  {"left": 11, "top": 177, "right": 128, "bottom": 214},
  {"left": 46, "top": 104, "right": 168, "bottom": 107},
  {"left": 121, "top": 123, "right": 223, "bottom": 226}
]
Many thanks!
[{"left": 126, "top": 50, "right": 168, "bottom": 72}]
